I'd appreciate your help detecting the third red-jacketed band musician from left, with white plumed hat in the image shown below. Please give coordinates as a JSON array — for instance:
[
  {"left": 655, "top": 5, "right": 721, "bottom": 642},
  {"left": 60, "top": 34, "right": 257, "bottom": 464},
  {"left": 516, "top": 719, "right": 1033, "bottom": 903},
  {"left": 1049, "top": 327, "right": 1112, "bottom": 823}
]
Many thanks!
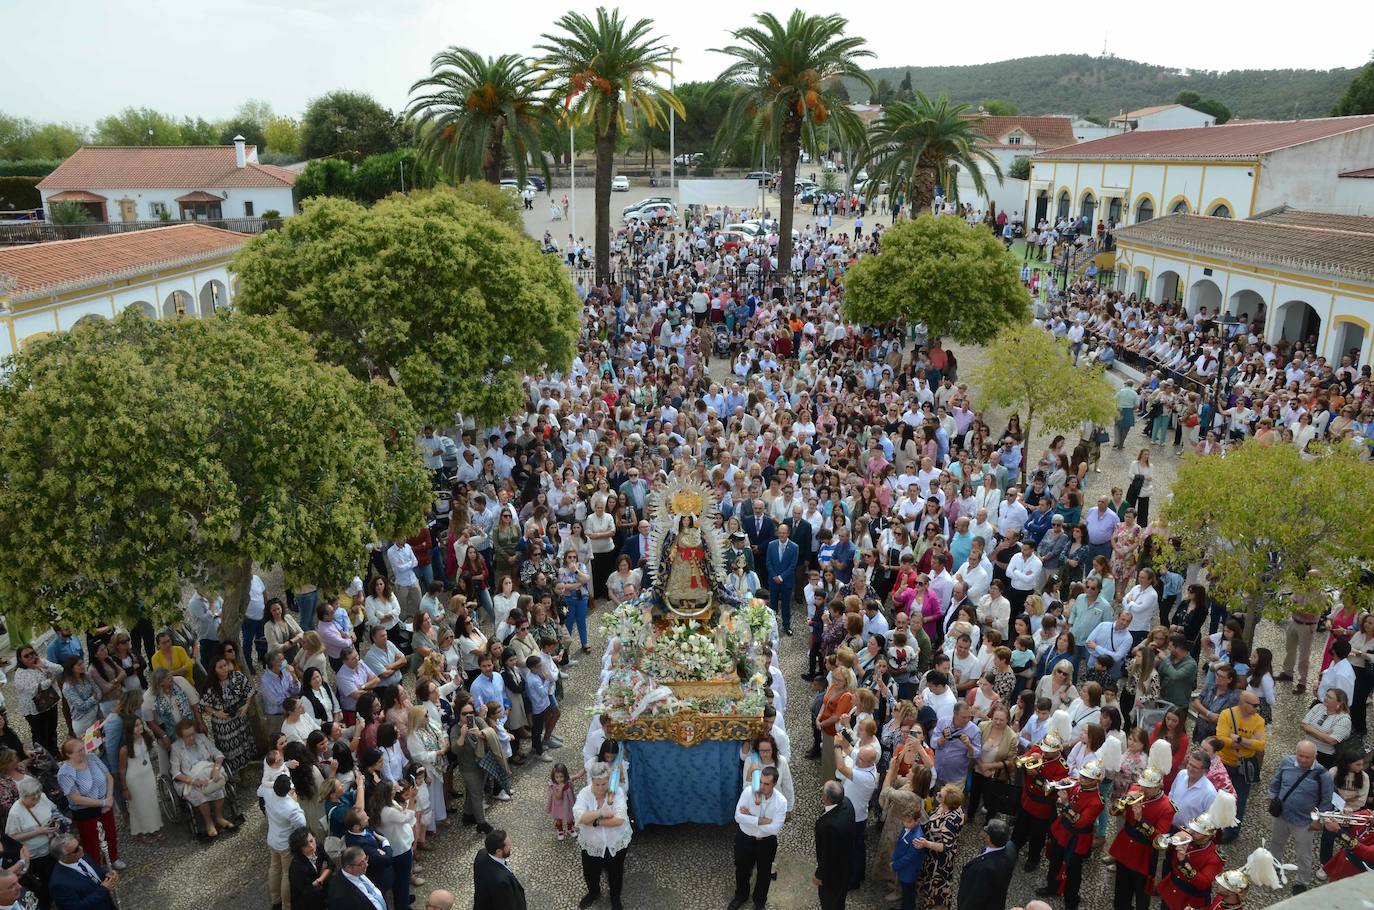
[{"left": 1107, "top": 740, "right": 1178, "bottom": 910}]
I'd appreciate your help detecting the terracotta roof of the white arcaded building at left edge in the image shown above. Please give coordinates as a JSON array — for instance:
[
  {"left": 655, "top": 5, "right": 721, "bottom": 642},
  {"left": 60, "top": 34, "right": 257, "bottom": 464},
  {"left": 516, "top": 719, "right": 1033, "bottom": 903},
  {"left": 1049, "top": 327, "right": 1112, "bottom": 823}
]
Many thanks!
[{"left": 0, "top": 224, "right": 247, "bottom": 304}]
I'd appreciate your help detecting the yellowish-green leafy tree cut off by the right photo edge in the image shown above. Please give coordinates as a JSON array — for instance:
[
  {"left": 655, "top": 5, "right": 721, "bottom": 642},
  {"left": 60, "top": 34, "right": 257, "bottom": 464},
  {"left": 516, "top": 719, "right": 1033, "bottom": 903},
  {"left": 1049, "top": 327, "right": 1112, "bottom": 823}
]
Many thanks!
[{"left": 1158, "top": 443, "right": 1374, "bottom": 630}]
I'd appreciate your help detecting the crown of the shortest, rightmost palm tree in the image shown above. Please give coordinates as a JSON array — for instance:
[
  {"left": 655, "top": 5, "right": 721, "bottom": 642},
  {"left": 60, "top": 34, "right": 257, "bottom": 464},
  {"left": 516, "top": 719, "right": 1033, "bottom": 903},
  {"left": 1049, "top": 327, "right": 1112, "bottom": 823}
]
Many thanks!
[{"left": 864, "top": 92, "right": 1002, "bottom": 214}]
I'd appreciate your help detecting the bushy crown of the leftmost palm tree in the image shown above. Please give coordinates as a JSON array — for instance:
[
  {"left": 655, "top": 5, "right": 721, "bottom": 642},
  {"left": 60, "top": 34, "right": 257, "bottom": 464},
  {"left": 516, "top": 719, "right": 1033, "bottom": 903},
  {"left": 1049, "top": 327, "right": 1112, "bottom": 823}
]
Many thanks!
[{"left": 408, "top": 47, "right": 548, "bottom": 186}]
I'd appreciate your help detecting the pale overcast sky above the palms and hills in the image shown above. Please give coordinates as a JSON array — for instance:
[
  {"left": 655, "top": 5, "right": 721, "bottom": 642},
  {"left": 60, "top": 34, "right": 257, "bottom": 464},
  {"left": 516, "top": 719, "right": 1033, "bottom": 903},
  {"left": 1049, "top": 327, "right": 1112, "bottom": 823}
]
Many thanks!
[{"left": 0, "top": 0, "right": 1374, "bottom": 125}]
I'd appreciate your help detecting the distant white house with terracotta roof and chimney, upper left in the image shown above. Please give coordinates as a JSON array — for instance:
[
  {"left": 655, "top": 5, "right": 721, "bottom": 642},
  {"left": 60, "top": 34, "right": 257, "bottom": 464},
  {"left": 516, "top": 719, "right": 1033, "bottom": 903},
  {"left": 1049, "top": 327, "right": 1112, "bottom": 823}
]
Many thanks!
[{"left": 38, "top": 136, "right": 297, "bottom": 224}]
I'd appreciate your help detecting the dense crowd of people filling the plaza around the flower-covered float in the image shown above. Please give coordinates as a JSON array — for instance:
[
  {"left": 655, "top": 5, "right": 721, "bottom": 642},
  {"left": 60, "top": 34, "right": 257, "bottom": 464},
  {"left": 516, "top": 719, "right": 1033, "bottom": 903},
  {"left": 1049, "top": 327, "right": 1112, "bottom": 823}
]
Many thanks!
[{"left": 0, "top": 196, "right": 1374, "bottom": 910}]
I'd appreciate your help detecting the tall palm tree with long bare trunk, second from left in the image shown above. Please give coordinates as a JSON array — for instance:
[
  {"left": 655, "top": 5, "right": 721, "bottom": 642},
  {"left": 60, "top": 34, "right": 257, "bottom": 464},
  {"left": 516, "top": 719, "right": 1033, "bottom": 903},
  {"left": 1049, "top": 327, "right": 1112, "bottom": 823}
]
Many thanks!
[{"left": 536, "top": 7, "right": 686, "bottom": 282}]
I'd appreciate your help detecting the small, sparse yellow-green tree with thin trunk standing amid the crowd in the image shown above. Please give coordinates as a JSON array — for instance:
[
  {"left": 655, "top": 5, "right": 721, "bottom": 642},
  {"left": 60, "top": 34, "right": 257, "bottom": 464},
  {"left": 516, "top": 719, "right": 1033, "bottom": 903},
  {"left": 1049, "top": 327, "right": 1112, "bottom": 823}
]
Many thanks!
[{"left": 967, "top": 325, "right": 1116, "bottom": 481}]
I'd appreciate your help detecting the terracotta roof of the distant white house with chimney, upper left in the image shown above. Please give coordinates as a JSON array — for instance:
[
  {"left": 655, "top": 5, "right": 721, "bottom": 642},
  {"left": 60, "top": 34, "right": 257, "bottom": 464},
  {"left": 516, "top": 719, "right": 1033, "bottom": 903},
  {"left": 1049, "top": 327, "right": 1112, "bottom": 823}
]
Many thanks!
[{"left": 38, "top": 146, "right": 295, "bottom": 190}]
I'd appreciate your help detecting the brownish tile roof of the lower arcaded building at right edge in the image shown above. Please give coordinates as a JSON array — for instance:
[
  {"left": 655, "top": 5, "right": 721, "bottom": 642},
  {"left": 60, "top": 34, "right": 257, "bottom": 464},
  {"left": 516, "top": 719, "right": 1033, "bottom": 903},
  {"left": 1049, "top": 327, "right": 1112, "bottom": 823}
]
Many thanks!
[{"left": 1116, "top": 212, "right": 1374, "bottom": 283}]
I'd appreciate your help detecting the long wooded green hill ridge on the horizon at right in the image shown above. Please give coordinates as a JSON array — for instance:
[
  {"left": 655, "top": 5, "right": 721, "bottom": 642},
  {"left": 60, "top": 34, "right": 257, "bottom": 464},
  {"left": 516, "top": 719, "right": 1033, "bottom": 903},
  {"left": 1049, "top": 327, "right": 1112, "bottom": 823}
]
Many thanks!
[{"left": 845, "top": 54, "right": 1359, "bottom": 120}]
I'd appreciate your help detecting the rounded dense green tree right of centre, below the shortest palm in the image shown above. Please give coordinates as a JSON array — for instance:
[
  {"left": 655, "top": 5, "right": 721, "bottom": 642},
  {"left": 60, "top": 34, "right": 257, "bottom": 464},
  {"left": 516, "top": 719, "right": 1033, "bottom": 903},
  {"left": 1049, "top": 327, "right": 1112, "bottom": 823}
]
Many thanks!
[{"left": 845, "top": 214, "right": 1031, "bottom": 344}]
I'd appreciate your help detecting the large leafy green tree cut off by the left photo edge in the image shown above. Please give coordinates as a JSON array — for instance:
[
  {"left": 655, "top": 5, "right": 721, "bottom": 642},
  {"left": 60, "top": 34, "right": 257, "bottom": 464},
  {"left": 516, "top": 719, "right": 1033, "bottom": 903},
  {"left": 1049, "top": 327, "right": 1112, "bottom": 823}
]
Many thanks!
[{"left": 0, "top": 312, "right": 429, "bottom": 634}]
